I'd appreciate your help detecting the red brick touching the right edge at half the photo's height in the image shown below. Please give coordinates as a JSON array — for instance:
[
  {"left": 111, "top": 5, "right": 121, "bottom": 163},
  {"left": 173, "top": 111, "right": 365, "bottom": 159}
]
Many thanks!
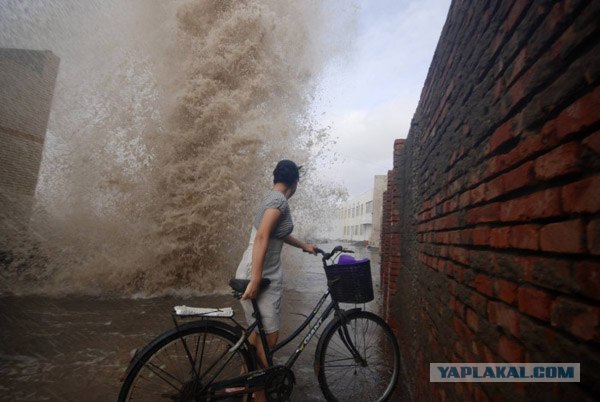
[{"left": 562, "top": 175, "right": 600, "bottom": 213}]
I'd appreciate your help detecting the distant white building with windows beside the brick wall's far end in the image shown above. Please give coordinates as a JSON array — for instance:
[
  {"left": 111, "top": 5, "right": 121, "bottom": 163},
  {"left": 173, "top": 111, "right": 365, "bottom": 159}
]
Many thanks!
[{"left": 335, "top": 175, "right": 387, "bottom": 247}]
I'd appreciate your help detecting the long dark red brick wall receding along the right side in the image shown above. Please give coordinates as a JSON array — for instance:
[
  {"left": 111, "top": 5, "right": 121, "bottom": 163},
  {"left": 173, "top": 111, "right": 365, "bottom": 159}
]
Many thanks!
[{"left": 381, "top": 0, "right": 600, "bottom": 401}]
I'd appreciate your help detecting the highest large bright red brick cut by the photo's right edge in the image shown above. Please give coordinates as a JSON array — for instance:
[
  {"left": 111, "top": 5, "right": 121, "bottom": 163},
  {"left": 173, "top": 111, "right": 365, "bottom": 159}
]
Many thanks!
[{"left": 556, "top": 87, "right": 600, "bottom": 138}]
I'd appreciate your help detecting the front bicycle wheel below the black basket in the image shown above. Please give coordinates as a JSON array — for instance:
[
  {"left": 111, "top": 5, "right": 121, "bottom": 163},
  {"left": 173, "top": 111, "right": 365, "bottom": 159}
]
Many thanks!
[{"left": 315, "top": 311, "right": 400, "bottom": 401}]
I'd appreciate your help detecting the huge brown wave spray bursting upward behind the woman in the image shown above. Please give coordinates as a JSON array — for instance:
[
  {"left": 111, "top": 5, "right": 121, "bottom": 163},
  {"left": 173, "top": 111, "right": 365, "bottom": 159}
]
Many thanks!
[{"left": 2, "top": 0, "right": 352, "bottom": 295}]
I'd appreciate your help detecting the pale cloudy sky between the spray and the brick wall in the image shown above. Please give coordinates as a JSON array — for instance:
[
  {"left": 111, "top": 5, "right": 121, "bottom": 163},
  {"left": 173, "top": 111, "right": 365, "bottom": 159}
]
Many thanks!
[{"left": 316, "top": 0, "right": 450, "bottom": 196}]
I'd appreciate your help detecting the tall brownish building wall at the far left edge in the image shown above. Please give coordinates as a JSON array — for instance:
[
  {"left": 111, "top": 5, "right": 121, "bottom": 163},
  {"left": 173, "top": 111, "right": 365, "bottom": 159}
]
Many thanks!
[{"left": 0, "top": 49, "right": 59, "bottom": 234}]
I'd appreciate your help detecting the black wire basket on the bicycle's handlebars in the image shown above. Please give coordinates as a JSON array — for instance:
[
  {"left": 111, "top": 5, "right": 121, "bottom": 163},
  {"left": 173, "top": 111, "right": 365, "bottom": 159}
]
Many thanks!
[{"left": 325, "top": 260, "right": 374, "bottom": 303}]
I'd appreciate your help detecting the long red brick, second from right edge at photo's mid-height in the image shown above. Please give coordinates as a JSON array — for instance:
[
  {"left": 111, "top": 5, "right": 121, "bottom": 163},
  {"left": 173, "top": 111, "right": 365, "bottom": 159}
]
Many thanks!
[{"left": 500, "top": 188, "right": 562, "bottom": 222}]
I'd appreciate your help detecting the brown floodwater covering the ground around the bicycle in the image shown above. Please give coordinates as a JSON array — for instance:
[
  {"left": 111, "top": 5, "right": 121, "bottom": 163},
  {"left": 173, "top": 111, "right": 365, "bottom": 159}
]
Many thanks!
[{"left": 0, "top": 245, "right": 380, "bottom": 401}]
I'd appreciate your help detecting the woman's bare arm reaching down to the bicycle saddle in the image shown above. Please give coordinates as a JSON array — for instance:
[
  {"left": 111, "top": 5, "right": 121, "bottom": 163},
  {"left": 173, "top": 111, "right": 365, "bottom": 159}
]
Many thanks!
[{"left": 242, "top": 208, "right": 281, "bottom": 300}]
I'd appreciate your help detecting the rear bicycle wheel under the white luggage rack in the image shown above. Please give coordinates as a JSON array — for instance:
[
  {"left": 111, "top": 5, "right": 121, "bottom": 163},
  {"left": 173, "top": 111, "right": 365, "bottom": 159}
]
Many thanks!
[{"left": 118, "top": 321, "right": 255, "bottom": 402}]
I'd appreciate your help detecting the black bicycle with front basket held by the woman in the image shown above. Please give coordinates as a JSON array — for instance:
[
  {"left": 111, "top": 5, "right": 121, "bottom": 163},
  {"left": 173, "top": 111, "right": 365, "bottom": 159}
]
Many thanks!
[{"left": 119, "top": 246, "right": 400, "bottom": 401}]
